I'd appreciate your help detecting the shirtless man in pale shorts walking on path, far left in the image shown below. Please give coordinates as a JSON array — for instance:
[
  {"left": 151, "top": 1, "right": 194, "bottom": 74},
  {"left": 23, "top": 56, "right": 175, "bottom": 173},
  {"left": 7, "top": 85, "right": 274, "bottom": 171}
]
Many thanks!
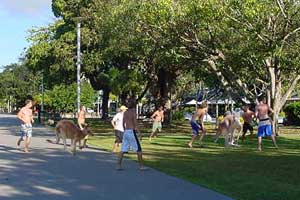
[{"left": 17, "top": 100, "right": 34, "bottom": 153}]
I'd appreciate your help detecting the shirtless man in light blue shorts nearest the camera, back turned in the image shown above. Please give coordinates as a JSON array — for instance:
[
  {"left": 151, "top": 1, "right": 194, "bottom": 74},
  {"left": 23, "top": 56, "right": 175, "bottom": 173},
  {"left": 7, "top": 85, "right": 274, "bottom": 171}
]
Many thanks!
[{"left": 116, "top": 99, "right": 146, "bottom": 170}]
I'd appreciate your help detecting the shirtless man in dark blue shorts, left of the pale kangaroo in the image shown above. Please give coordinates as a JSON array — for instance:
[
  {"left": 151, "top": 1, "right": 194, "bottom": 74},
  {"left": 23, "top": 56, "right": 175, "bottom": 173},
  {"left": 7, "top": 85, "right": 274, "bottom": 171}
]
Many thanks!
[{"left": 188, "top": 102, "right": 208, "bottom": 148}]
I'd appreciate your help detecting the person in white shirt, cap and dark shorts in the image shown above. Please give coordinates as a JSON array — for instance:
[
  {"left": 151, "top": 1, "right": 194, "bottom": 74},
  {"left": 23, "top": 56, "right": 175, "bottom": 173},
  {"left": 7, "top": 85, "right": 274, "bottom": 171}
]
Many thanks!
[{"left": 111, "top": 106, "right": 127, "bottom": 152}]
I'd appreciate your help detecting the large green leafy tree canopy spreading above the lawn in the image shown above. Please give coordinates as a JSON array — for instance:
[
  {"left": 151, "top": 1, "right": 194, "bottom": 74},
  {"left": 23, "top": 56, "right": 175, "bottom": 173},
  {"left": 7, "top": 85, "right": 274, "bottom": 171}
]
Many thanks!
[{"left": 19, "top": 0, "right": 300, "bottom": 127}]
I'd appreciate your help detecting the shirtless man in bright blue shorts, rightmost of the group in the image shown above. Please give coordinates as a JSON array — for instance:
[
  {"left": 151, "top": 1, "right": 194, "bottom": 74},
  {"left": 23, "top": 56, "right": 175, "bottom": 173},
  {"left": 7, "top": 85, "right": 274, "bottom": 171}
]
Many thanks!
[{"left": 255, "top": 98, "right": 278, "bottom": 151}]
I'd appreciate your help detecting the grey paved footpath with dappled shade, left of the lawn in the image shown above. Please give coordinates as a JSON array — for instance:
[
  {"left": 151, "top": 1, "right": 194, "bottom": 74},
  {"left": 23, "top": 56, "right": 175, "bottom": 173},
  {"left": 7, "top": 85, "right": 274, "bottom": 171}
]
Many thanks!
[{"left": 0, "top": 114, "right": 231, "bottom": 200}]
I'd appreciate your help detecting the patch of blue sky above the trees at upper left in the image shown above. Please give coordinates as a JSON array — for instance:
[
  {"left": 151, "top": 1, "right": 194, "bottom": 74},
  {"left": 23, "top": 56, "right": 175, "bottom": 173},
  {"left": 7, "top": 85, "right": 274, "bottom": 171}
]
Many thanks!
[{"left": 0, "top": 0, "right": 54, "bottom": 71}]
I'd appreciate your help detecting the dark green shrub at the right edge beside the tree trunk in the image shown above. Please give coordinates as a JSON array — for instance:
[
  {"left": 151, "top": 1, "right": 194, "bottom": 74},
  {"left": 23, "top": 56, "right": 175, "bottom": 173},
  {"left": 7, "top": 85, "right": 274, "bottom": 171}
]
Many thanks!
[{"left": 284, "top": 102, "right": 300, "bottom": 125}]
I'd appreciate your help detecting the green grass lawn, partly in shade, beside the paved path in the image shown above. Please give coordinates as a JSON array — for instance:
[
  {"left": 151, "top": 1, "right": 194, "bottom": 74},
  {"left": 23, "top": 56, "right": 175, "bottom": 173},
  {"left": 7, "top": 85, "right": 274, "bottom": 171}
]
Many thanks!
[{"left": 89, "top": 121, "right": 300, "bottom": 200}]
